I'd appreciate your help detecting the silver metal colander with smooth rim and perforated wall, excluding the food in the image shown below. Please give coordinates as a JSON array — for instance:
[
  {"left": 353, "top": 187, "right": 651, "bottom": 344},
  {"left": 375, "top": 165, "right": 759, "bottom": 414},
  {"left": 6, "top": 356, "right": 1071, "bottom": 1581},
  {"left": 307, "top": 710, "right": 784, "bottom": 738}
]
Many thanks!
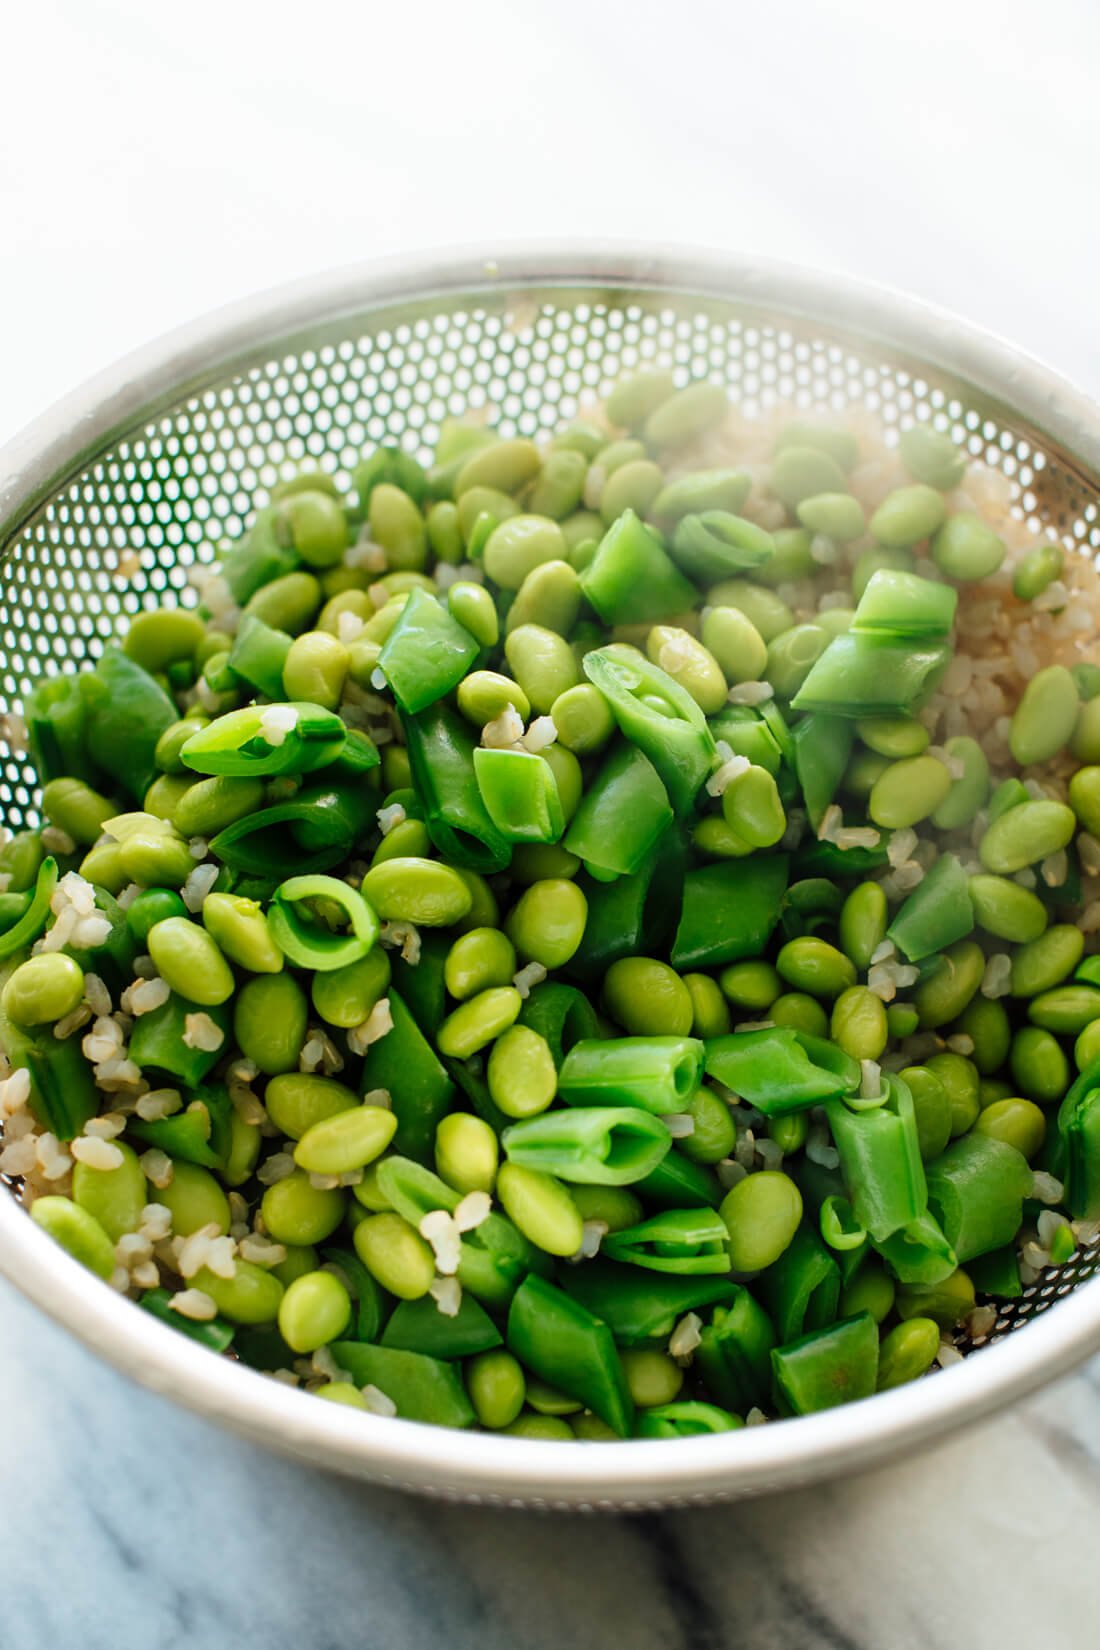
[{"left": 0, "top": 248, "right": 1100, "bottom": 1506}]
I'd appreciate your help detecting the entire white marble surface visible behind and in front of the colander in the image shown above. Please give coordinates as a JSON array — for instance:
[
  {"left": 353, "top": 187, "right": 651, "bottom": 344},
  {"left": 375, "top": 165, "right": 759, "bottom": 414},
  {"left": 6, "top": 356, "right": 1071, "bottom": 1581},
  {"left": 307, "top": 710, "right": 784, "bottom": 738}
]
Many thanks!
[{"left": 0, "top": 0, "right": 1100, "bottom": 1650}]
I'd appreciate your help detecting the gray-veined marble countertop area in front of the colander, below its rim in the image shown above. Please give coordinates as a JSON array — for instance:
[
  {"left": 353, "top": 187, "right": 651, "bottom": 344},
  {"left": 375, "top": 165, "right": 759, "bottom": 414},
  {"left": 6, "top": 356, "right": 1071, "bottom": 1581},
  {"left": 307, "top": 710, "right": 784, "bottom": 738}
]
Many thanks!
[{"left": 0, "top": 1285, "right": 1100, "bottom": 1650}]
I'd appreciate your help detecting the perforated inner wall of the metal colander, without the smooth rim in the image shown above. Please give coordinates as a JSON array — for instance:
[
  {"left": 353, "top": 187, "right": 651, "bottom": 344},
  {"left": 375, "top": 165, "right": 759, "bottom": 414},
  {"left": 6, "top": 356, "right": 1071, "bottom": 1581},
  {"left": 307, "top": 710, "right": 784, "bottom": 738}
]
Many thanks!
[{"left": 0, "top": 285, "right": 1100, "bottom": 1338}]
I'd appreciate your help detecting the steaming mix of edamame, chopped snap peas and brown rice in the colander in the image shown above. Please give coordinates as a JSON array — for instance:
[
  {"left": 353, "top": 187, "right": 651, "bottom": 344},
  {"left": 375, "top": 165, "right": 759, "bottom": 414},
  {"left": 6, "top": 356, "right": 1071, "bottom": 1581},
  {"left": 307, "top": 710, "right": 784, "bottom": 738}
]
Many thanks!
[{"left": 0, "top": 370, "right": 1100, "bottom": 1440}]
